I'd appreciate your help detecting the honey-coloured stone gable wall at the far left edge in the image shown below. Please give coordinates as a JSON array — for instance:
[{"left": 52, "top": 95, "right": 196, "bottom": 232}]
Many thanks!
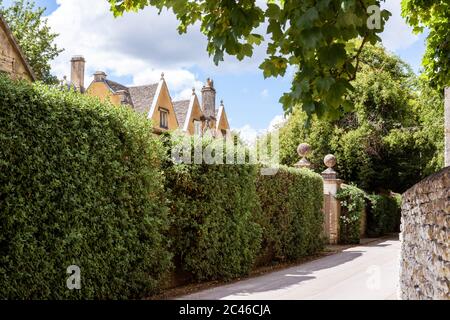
[{"left": 0, "top": 16, "right": 33, "bottom": 81}]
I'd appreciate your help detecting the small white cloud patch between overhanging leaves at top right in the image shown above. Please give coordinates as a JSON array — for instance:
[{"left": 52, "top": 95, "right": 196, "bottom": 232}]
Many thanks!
[{"left": 381, "top": 0, "right": 419, "bottom": 51}]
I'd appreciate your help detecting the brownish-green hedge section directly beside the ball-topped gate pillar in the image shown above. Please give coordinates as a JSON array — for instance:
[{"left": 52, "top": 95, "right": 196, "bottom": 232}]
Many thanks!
[{"left": 257, "top": 167, "right": 324, "bottom": 262}]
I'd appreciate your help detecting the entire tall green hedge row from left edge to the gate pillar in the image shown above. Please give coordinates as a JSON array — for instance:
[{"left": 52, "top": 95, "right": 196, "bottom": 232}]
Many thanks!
[{"left": 0, "top": 76, "right": 323, "bottom": 299}]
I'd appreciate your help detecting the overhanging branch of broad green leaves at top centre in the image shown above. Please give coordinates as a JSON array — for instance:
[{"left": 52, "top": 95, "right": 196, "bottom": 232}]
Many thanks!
[{"left": 108, "top": 0, "right": 390, "bottom": 117}]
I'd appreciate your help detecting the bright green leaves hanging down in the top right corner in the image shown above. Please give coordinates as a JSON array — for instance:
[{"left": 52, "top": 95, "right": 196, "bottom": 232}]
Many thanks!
[{"left": 402, "top": 0, "right": 450, "bottom": 92}]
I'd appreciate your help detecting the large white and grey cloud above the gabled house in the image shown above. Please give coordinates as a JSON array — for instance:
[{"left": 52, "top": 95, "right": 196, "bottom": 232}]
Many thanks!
[{"left": 48, "top": 0, "right": 264, "bottom": 98}]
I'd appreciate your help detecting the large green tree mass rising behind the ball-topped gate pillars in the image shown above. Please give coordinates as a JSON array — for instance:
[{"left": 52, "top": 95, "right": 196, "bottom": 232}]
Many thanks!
[{"left": 272, "top": 46, "right": 444, "bottom": 192}]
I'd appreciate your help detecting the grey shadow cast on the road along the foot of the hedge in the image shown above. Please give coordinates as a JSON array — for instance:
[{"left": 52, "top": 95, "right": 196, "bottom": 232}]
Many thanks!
[{"left": 179, "top": 251, "right": 364, "bottom": 300}]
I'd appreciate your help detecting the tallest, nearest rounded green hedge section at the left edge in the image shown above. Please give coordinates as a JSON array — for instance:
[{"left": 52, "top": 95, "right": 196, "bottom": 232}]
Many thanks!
[{"left": 0, "top": 76, "right": 171, "bottom": 299}]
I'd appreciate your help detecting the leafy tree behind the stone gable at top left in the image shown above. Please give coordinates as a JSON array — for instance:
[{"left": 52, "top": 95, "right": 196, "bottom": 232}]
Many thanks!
[{"left": 0, "top": 0, "right": 63, "bottom": 83}]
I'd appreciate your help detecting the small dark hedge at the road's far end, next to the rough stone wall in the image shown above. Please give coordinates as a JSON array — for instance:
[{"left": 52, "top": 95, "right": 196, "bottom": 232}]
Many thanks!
[{"left": 366, "top": 195, "right": 401, "bottom": 237}]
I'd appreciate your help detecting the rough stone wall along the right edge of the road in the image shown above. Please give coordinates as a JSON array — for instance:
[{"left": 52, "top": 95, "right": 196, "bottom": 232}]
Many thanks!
[{"left": 400, "top": 167, "right": 450, "bottom": 300}]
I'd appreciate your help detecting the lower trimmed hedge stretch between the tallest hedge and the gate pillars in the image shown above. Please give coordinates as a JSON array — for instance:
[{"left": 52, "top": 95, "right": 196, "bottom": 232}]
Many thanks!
[{"left": 165, "top": 135, "right": 324, "bottom": 280}]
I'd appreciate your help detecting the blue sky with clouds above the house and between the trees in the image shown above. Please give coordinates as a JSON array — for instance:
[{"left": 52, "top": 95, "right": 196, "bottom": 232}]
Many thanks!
[{"left": 4, "top": 0, "right": 426, "bottom": 140}]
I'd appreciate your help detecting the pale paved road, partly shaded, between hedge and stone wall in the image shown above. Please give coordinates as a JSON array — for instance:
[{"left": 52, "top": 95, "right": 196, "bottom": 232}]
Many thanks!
[{"left": 180, "top": 235, "right": 400, "bottom": 300}]
